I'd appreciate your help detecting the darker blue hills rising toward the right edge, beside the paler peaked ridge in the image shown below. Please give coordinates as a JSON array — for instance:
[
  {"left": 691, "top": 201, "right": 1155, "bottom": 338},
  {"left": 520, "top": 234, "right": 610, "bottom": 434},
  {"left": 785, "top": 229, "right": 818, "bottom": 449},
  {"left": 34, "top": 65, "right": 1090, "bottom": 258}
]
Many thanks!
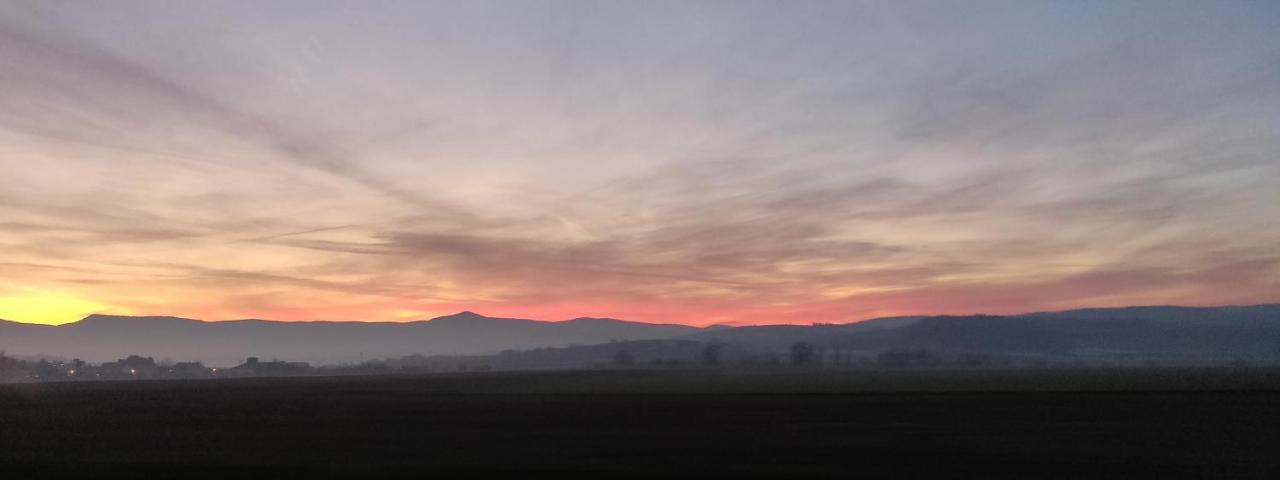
[{"left": 694, "top": 305, "right": 1280, "bottom": 362}]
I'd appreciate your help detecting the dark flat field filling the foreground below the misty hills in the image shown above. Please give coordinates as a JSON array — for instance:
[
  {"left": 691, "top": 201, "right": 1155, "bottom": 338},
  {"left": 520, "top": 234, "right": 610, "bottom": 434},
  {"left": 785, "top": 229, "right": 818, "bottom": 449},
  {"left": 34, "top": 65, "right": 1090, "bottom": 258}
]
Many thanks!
[{"left": 0, "top": 370, "right": 1280, "bottom": 479}]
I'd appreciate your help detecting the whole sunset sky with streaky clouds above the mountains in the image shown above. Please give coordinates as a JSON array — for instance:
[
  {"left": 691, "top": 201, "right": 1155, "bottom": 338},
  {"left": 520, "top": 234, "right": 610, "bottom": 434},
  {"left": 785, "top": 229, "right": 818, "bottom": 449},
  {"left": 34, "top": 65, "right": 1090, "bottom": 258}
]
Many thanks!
[{"left": 0, "top": 0, "right": 1280, "bottom": 325}]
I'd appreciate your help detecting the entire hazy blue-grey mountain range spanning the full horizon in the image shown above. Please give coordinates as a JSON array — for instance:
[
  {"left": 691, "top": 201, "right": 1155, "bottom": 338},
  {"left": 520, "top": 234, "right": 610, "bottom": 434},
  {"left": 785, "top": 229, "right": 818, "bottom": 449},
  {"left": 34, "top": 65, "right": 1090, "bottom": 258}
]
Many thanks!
[{"left": 0, "top": 305, "right": 1280, "bottom": 366}]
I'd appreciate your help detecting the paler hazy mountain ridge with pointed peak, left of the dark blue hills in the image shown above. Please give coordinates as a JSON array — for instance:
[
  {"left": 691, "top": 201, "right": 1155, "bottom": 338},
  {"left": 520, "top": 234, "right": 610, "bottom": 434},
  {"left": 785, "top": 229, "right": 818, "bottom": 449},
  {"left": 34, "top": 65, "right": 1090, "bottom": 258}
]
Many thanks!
[{"left": 0, "top": 311, "right": 699, "bottom": 366}]
